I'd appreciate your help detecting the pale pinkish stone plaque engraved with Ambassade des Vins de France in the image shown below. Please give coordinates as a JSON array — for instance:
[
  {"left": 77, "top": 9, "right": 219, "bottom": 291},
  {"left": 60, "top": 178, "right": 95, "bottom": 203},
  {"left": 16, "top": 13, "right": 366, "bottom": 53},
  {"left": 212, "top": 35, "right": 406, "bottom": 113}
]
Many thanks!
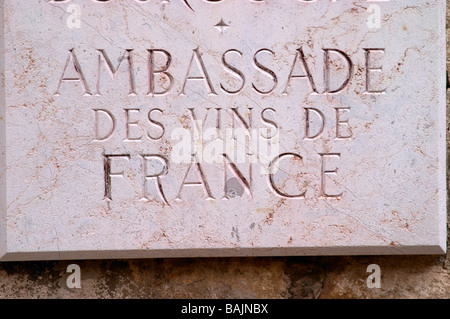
[{"left": 0, "top": 0, "right": 446, "bottom": 260}]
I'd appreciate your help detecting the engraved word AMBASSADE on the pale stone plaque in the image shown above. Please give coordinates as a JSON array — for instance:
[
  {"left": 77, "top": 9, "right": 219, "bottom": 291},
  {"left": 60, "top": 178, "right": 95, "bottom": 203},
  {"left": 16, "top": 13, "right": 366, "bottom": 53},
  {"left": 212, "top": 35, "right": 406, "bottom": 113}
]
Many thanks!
[{"left": 55, "top": 47, "right": 386, "bottom": 96}]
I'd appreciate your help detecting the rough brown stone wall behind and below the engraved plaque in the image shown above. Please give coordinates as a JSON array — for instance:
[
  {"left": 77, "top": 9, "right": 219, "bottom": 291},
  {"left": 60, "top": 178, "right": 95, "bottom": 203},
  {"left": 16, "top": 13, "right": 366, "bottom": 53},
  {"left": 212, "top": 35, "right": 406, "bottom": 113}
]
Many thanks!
[{"left": 0, "top": 5, "right": 450, "bottom": 298}]
